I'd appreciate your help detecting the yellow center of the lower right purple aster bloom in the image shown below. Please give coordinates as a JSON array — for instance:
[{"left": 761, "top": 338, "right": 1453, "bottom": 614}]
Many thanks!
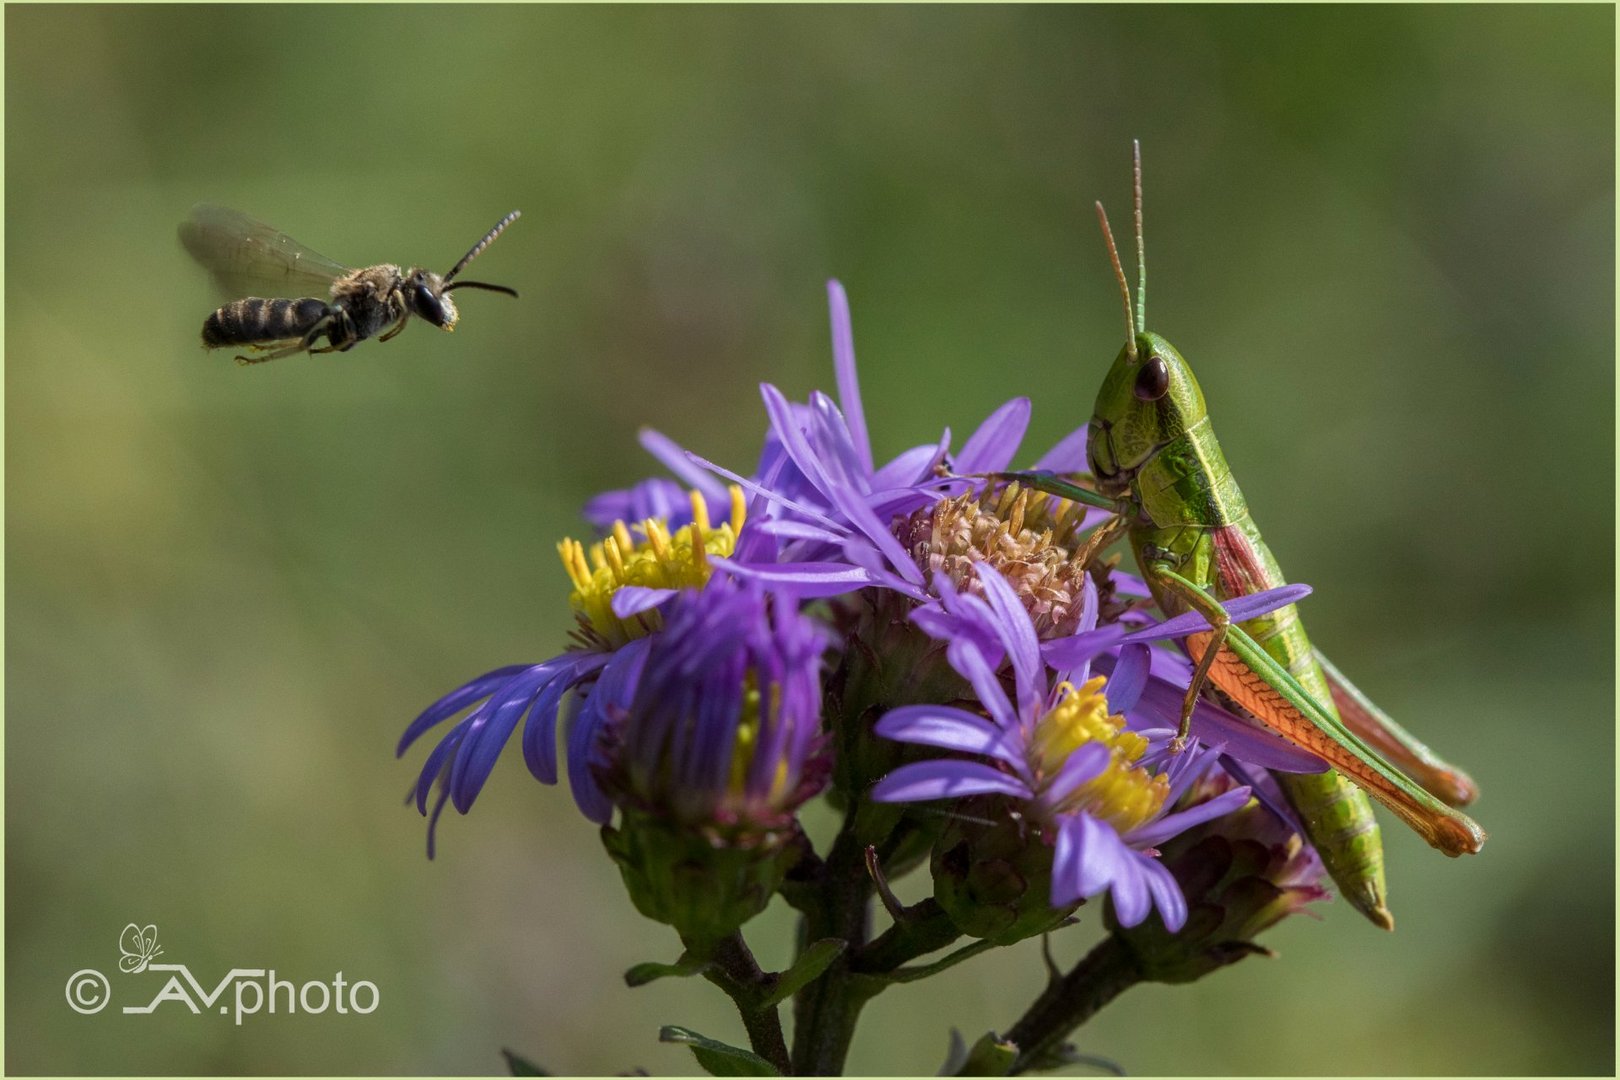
[{"left": 1030, "top": 675, "right": 1170, "bottom": 832}]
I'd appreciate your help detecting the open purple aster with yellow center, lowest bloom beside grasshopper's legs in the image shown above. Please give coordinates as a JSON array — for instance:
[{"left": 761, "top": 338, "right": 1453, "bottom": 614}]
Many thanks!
[{"left": 872, "top": 563, "right": 1320, "bottom": 929}]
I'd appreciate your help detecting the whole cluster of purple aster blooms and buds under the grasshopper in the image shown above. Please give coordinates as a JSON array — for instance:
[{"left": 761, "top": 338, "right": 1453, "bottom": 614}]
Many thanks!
[{"left": 399, "top": 282, "right": 1320, "bottom": 950}]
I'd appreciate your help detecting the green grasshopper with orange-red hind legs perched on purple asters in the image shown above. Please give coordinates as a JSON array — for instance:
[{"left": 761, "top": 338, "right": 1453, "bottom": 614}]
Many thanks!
[{"left": 996, "top": 144, "right": 1486, "bottom": 929}]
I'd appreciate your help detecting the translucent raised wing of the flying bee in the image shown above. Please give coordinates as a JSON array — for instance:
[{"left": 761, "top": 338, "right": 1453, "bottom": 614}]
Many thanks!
[{"left": 180, "top": 204, "right": 348, "bottom": 298}]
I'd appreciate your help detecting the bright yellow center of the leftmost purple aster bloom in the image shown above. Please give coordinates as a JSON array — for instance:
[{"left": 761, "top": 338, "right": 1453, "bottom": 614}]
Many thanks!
[{"left": 557, "top": 486, "right": 747, "bottom": 648}]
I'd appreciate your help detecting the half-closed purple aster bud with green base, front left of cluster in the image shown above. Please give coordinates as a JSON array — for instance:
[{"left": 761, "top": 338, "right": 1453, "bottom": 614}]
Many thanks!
[{"left": 593, "top": 578, "right": 826, "bottom": 947}]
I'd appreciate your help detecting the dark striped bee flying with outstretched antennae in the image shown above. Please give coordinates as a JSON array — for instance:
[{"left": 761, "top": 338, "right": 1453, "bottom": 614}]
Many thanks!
[{"left": 180, "top": 206, "right": 518, "bottom": 364}]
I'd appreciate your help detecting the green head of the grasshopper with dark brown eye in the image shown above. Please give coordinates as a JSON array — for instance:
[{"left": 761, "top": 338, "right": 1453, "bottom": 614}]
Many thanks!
[{"left": 1087, "top": 332, "right": 1204, "bottom": 492}]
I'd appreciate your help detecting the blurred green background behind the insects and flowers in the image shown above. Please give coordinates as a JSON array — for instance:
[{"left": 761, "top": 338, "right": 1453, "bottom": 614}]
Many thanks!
[{"left": 5, "top": 5, "right": 1615, "bottom": 1074}]
